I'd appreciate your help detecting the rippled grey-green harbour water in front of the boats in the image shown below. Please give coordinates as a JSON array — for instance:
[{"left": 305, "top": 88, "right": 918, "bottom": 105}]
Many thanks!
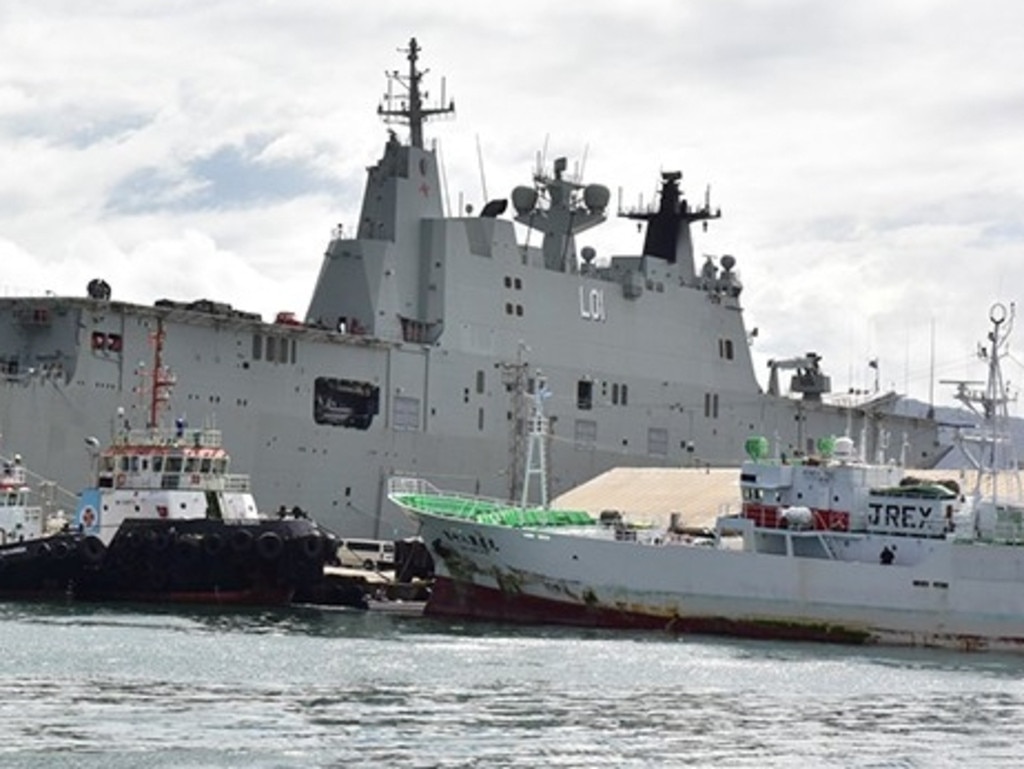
[{"left": 0, "top": 603, "right": 1024, "bottom": 769}]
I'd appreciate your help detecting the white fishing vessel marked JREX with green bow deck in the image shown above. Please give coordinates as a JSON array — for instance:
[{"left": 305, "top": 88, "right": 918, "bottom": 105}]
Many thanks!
[{"left": 390, "top": 305, "right": 1024, "bottom": 651}]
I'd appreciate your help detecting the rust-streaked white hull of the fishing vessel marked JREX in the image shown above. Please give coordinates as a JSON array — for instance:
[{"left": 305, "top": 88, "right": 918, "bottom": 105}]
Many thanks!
[{"left": 417, "top": 514, "right": 1024, "bottom": 651}]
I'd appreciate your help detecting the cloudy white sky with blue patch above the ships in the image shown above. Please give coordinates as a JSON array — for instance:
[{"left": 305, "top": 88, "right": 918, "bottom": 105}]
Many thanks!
[{"left": 0, "top": 0, "right": 1024, "bottom": 402}]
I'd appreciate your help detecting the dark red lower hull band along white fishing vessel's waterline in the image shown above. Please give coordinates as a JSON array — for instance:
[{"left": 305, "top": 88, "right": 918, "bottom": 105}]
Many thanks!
[{"left": 424, "top": 576, "right": 872, "bottom": 644}]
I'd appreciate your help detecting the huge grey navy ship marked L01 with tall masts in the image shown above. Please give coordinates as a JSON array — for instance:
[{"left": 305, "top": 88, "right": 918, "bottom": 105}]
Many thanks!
[{"left": 0, "top": 39, "right": 944, "bottom": 538}]
